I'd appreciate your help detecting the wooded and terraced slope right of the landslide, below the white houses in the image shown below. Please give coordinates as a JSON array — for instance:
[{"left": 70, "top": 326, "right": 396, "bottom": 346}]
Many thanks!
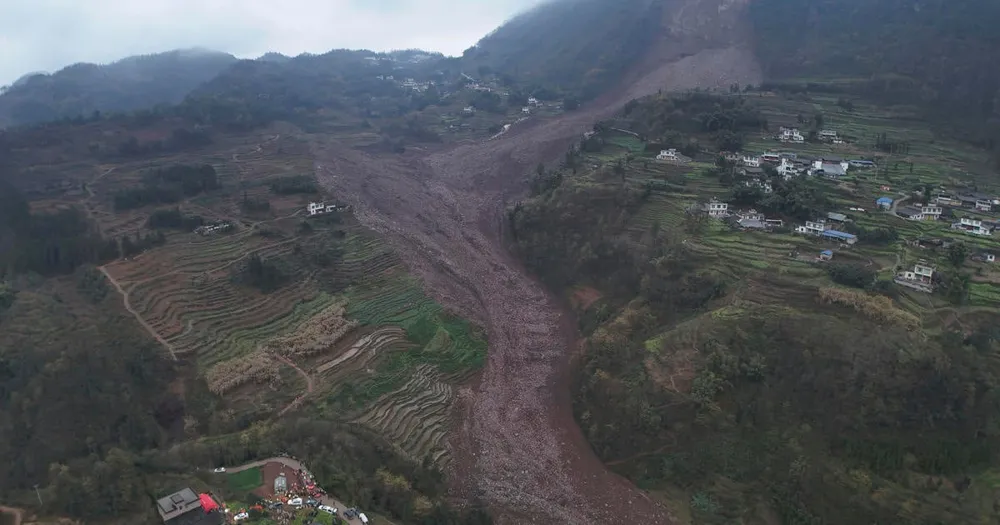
[{"left": 509, "top": 93, "right": 1000, "bottom": 525}]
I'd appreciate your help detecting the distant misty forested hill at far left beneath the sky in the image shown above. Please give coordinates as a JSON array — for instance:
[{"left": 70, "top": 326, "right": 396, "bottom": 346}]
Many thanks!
[{"left": 0, "top": 49, "right": 236, "bottom": 127}]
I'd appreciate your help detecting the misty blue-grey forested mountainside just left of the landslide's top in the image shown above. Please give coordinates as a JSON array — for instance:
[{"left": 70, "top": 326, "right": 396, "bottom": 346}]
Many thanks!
[{"left": 463, "top": 0, "right": 664, "bottom": 99}]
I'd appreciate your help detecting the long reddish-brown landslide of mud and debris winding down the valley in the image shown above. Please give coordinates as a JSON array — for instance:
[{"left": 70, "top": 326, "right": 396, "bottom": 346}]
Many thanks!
[{"left": 314, "top": 0, "right": 759, "bottom": 524}]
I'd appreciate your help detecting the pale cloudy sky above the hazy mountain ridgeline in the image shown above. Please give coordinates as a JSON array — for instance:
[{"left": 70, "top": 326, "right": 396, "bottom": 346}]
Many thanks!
[{"left": 0, "top": 0, "right": 540, "bottom": 85}]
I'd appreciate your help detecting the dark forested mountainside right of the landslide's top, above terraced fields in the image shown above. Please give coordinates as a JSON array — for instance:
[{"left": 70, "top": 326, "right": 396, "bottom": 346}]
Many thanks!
[{"left": 750, "top": 0, "right": 1000, "bottom": 144}]
